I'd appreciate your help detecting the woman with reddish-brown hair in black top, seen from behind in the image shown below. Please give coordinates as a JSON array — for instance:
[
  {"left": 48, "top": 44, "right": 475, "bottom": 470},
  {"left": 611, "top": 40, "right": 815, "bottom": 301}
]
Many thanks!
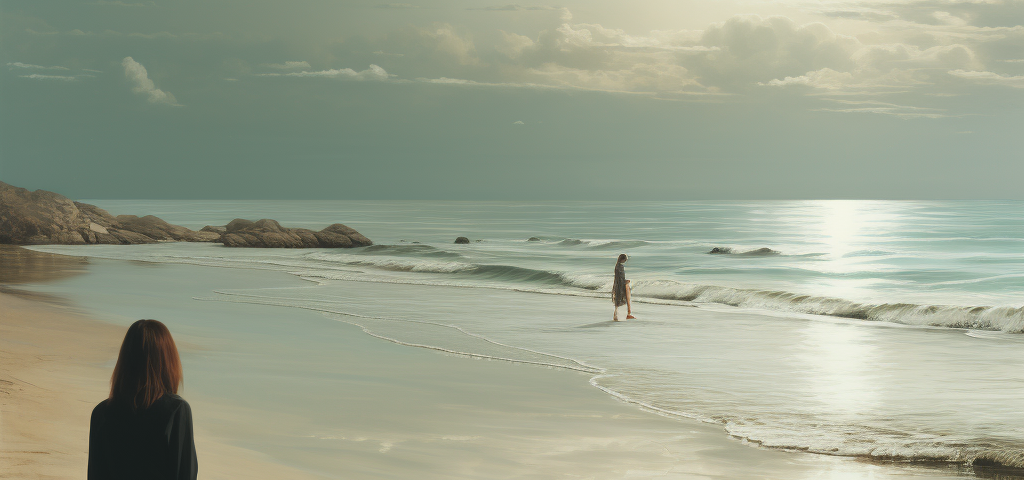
[{"left": 88, "top": 320, "right": 199, "bottom": 480}]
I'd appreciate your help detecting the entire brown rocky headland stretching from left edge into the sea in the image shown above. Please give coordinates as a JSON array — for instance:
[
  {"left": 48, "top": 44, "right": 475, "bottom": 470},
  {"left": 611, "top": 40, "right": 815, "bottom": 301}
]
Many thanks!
[{"left": 0, "top": 182, "right": 373, "bottom": 248}]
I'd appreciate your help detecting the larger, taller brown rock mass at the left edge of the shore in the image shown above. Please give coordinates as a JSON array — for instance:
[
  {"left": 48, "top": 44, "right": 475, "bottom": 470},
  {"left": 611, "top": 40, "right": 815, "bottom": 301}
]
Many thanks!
[{"left": 0, "top": 182, "right": 219, "bottom": 245}]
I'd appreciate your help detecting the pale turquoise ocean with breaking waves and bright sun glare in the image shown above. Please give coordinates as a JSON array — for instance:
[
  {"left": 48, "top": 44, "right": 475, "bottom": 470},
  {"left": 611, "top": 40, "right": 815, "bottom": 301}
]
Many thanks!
[{"left": 25, "top": 201, "right": 1024, "bottom": 468}]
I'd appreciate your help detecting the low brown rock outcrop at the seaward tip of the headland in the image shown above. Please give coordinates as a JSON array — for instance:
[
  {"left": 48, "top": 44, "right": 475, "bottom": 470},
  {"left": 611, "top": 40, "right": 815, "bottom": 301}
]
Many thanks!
[{"left": 217, "top": 218, "right": 374, "bottom": 249}]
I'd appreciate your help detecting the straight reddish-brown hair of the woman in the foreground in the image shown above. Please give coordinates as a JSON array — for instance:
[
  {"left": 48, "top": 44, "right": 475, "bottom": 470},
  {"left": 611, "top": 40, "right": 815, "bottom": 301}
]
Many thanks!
[{"left": 111, "top": 320, "right": 182, "bottom": 409}]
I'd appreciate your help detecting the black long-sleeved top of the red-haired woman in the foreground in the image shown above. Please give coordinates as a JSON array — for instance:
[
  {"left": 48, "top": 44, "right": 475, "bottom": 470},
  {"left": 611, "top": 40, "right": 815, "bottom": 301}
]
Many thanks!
[{"left": 88, "top": 394, "right": 199, "bottom": 480}]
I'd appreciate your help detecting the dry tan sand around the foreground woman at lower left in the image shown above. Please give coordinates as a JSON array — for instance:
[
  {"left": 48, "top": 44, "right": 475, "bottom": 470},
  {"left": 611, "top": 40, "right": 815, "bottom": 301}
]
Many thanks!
[{"left": 0, "top": 290, "right": 331, "bottom": 479}]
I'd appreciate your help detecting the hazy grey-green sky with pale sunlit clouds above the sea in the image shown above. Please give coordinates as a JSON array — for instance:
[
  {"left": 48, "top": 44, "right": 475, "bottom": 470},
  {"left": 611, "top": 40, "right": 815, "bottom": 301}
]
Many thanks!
[{"left": 0, "top": 0, "right": 1024, "bottom": 201}]
